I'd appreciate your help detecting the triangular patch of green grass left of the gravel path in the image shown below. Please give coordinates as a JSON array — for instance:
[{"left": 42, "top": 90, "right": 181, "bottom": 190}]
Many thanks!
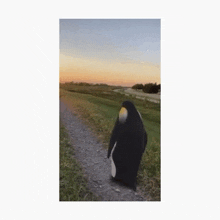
[{"left": 60, "top": 125, "right": 98, "bottom": 201}]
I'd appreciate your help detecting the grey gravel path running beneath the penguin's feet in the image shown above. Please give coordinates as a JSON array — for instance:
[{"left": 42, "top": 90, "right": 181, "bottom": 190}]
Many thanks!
[{"left": 60, "top": 101, "right": 149, "bottom": 201}]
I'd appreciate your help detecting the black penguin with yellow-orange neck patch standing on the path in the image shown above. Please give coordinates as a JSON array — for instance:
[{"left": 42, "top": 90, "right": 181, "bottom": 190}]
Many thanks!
[{"left": 107, "top": 100, "right": 147, "bottom": 191}]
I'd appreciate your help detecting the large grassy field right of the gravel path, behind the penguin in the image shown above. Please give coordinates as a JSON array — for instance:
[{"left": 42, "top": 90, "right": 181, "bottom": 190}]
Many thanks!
[{"left": 60, "top": 84, "right": 160, "bottom": 201}]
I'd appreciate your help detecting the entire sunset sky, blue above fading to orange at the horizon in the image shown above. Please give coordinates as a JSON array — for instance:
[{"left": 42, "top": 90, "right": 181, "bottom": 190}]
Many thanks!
[{"left": 60, "top": 19, "right": 161, "bottom": 86}]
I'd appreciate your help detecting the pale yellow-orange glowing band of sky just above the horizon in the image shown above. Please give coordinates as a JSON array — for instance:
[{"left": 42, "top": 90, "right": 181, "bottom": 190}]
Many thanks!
[{"left": 60, "top": 54, "right": 160, "bottom": 86}]
